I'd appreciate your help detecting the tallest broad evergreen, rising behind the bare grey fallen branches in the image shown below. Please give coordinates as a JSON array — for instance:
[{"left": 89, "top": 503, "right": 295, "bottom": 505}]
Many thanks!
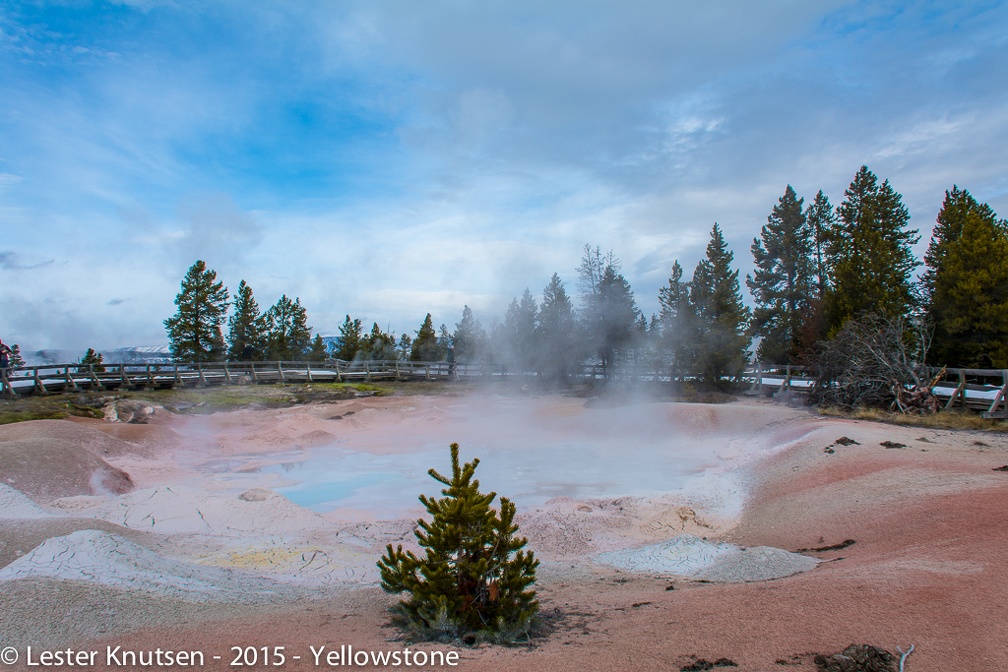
[{"left": 828, "top": 166, "right": 920, "bottom": 329}]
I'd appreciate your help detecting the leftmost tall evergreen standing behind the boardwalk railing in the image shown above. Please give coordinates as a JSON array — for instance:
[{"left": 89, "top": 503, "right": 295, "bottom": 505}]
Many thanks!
[{"left": 164, "top": 260, "right": 228, "bottom": 362}]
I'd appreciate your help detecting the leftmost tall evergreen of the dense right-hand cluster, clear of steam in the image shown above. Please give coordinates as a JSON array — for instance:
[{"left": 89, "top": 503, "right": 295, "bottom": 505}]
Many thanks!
[{"left": 746, "top": 184, "right": 815, "bottom": 364}]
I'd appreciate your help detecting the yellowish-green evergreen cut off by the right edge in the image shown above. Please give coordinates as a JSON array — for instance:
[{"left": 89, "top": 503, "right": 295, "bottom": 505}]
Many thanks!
[{"left": 922, "top": 187, "right": 1008, "bottom": 369}]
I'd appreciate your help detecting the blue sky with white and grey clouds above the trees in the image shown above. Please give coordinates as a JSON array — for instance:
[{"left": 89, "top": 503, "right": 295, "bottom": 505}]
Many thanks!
[{"left": 0, "top": 0, "right": 1008, "bottom": 352}]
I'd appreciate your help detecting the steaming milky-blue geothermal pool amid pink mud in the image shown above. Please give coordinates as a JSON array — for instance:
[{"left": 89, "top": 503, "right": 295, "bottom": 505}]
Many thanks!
[{"left": 185, "top": 397, "right": 780, "bottom": 519}]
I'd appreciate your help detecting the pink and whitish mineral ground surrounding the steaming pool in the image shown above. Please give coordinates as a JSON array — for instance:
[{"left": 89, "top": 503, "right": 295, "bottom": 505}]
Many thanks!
[{"left": 0, "top": 397, "right": 1008, "bottom": 672}]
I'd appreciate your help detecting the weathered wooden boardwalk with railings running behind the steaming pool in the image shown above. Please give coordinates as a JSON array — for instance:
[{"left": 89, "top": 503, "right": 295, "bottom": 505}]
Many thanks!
[{"left": 0, "top": 360, "right": 1008, "bottom": 418}]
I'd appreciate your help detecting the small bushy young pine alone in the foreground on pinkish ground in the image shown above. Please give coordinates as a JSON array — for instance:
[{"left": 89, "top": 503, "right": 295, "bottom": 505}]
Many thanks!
[{"left": 378, "top": 443, "right": 539, "bottom": 644}]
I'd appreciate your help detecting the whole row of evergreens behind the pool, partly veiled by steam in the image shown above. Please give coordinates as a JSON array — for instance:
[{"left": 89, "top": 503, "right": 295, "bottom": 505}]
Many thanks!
[{"left": 164, "top": 166, "right": 1008, "bottom": 386}]
